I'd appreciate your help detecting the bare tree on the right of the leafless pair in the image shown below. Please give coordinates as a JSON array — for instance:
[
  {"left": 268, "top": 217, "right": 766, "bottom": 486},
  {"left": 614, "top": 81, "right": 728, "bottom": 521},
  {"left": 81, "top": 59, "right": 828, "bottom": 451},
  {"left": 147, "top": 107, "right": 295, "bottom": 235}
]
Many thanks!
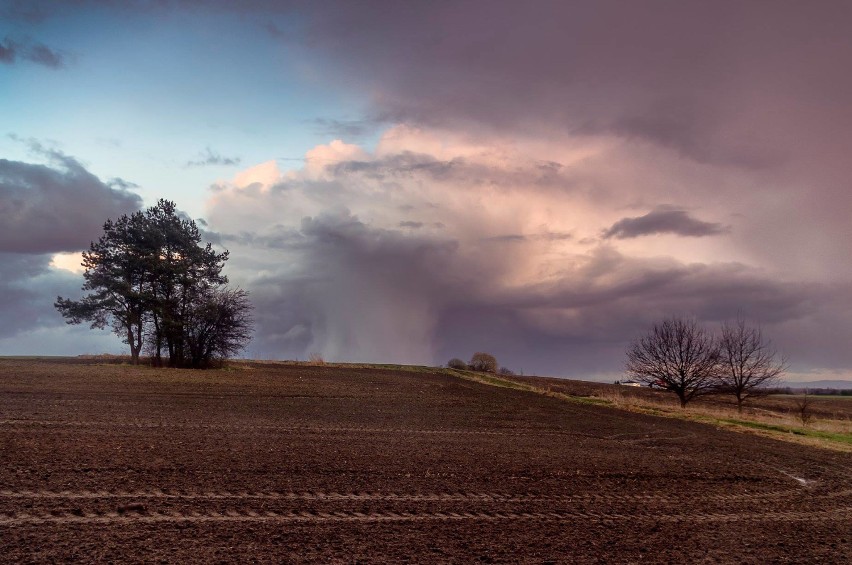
[{"left": 719, "top": 318, "right": 786, "bottom": 412}]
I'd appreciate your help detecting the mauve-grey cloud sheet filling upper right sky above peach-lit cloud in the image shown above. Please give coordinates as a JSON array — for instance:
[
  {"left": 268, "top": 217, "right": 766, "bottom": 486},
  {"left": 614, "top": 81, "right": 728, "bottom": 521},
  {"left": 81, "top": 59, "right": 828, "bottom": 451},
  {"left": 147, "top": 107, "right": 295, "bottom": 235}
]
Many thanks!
[{"left": 288, "top": 0, "right": 852, "bottom": 279}]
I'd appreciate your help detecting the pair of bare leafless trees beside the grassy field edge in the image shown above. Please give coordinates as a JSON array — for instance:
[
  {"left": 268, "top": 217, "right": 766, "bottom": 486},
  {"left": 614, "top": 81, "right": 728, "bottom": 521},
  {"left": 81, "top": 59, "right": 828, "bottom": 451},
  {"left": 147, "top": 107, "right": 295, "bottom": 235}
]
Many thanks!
[{"left": 627, "top": 312, "right": 786, "bottom": 411}]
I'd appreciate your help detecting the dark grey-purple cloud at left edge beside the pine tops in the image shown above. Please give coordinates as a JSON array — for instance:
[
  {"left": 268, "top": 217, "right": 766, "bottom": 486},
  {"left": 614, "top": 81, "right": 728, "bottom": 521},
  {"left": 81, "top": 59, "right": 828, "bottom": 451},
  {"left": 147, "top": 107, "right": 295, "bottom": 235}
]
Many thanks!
[{"left": 0, "top": 144, "right": 142, "bottom": 254}]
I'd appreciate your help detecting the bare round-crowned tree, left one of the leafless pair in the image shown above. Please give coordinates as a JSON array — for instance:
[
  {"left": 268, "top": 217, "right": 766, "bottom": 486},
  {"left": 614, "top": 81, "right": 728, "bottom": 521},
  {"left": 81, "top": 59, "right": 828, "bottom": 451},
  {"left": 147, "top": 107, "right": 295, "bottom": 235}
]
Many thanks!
[{"left": 627, "top": 318, "right": 719, "bottom": 407}]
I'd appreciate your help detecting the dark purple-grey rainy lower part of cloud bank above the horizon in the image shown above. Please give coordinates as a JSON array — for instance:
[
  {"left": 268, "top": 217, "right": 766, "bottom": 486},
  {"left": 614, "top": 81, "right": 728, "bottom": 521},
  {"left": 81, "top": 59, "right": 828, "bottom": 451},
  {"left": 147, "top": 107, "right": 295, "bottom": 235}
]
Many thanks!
[{"left": 227, "top": 213, "right": 832, "bottom": 377}]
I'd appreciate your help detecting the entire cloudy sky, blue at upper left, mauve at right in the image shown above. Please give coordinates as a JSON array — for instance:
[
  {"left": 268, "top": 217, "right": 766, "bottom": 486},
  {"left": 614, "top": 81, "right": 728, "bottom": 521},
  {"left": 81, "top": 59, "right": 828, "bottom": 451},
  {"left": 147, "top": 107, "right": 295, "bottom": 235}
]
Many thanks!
[{"left": 0, "top": 0, "right": 852, "bottom": 380}]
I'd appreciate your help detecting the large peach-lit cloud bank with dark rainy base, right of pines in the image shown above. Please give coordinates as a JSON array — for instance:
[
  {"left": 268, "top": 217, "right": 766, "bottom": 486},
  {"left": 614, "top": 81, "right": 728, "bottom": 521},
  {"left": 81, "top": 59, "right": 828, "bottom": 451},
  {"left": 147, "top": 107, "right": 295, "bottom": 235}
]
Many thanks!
[{"left": 203, "top": 126, "right": 852, "bottom": 376}]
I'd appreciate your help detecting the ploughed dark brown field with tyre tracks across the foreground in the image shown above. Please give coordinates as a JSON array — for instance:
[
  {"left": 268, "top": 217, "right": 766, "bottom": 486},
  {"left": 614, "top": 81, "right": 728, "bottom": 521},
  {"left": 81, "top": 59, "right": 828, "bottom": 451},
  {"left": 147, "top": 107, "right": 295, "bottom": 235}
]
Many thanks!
[{"left": 0, "top": 359, "right": 852, "bottom": 563}]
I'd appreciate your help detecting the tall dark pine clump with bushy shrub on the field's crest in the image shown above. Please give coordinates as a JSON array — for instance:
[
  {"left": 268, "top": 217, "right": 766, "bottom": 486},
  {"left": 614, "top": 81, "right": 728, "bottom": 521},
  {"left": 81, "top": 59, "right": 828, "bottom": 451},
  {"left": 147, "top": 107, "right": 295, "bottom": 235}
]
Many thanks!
[{"left": 55, "top": 200, "right": 252, "bottom": 368}]
